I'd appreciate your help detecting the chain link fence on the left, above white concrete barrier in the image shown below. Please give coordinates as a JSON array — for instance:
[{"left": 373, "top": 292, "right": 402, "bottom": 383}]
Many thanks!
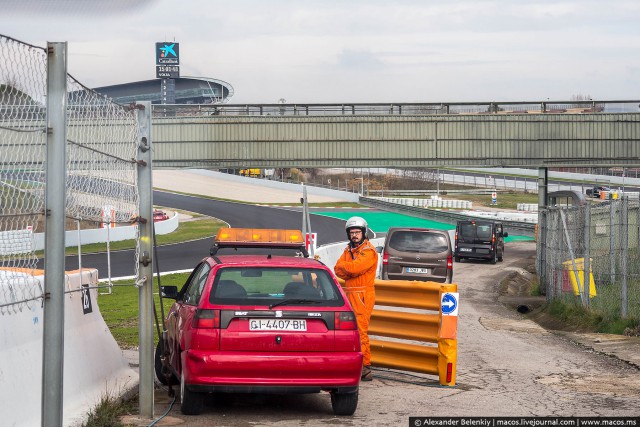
[{"left": 0, "top": 35, "right": 139, "bottom": 314}]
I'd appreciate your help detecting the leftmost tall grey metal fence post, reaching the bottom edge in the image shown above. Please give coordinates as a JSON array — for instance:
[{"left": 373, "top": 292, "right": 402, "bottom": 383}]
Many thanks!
[{"left": 41, "top": 43, "right": 67, "bottom": 427}]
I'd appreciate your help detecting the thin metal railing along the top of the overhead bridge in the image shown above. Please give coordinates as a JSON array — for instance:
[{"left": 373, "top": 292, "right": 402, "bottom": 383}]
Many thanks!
[{"left": 153, "top": 100, "right": 640, "bottom": 117}]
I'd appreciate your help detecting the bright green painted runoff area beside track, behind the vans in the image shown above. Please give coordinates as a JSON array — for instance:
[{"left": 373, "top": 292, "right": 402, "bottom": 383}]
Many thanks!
[{"left": 313, "top": 210, "right": 533, "bottom": 242}]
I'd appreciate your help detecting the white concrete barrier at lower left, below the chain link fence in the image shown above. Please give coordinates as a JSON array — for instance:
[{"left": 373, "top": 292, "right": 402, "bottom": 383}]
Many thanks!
[{"left": 0, "top": 269, "right": 138, "bottom": 427}]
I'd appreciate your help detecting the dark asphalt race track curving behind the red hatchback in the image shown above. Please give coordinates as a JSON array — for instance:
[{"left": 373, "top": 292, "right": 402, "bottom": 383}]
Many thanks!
[{"left": 58, "top": 191, "right": 345, "bottom": 279}]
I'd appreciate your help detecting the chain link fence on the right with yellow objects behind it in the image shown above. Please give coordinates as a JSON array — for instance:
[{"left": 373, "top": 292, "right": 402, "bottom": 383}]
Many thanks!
[{"left": 538, "top": 197, "right": 640, "bottom": 318}]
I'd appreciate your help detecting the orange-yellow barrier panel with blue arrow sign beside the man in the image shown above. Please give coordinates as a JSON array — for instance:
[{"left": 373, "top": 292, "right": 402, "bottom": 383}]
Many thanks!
[{"left": 339, "top": 280, "right": 458, "bottom": 386}]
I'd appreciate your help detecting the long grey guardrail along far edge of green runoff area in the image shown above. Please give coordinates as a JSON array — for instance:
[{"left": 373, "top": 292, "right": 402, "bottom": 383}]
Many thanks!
[{"left": 360, "top": 197, "right": 535, "bottom": 237}]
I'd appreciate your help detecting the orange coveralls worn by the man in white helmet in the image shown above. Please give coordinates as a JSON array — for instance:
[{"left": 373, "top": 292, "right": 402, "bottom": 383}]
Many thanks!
[{"left": 333, "top": 239, "right": 378, "bottom": 366}]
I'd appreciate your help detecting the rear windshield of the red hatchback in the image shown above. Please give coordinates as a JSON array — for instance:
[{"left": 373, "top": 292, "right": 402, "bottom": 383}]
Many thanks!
[{"left": 209, "top": 267, "right": 344, "bottom": 307}]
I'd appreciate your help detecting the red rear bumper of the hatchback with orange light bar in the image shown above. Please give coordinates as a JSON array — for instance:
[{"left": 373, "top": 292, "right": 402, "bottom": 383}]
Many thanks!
[{"left": 182, "top": 350, "right": 362, "bottom": 393}]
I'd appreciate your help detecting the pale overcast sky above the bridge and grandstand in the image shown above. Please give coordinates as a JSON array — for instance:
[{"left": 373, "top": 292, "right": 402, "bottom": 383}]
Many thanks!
[{"left": 0, "top": 0, "right": 640, "bottom": 103}]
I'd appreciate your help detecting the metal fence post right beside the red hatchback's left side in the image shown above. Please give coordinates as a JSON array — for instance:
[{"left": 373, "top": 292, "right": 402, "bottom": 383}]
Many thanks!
[{"left": 136, "top": 101, "right": 154, "bottom": 418}]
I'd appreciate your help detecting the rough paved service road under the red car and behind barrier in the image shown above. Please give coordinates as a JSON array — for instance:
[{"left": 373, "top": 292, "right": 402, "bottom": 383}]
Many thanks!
[{"left": 135, "top": 242, "right": 640, "bottom": 427}]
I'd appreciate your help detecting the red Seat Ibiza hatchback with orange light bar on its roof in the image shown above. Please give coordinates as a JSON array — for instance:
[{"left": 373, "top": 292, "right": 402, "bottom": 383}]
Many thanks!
[{"left": 156, "top": 229, "right": 362, "bottom": 415}]
